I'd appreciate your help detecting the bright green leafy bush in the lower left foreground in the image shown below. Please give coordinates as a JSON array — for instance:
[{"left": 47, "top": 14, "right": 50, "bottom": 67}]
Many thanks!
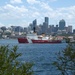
[{"left": 0, "top": 46, "right": 33, "bottom": 75}]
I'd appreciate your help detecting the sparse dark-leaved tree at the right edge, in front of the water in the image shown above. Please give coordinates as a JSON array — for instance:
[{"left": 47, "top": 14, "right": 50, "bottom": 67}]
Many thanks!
[{"left": 53, "top": 43, "right": 75, "bottom": 75}]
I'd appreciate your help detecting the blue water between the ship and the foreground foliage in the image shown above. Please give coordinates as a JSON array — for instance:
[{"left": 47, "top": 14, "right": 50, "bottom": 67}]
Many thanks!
[{"left": 0, "top": 39, "right": 66, "bottom": 75}]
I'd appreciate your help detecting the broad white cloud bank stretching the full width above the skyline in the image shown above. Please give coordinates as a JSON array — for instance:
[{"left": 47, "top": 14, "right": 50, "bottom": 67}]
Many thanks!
[{"left": 0, "top": 0, "right": 75, "bottom": 25}]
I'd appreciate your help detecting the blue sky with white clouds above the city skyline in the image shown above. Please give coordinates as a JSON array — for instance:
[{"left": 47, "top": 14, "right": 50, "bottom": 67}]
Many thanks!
[{"left": 0, "top": 0, "right": 75, "bottom": 29}]
